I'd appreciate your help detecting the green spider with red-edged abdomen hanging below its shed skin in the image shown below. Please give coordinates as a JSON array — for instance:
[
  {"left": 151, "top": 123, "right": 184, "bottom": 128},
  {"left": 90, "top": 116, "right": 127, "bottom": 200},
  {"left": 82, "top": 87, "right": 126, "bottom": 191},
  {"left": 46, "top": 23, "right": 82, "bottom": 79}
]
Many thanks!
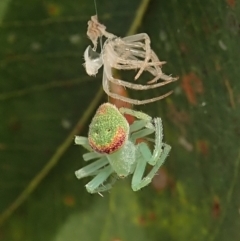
[{"left": 75, "top": 103, "right": 171, "bottom": 193}]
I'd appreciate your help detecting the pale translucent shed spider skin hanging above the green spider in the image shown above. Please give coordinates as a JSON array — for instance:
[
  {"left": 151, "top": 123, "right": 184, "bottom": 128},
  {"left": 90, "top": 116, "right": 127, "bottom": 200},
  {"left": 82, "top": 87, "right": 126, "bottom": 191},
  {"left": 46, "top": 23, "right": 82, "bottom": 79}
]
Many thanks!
[{"left": 84, "top": 16, "right": 178, "bottom": 105}]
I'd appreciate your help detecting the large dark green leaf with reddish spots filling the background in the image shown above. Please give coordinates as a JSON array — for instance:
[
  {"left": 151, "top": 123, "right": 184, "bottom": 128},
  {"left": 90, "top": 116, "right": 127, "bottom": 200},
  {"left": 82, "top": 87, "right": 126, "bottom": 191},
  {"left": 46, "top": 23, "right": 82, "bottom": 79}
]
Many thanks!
[{"left": 0, "top": 0, "right": 240, "bottom": 241}]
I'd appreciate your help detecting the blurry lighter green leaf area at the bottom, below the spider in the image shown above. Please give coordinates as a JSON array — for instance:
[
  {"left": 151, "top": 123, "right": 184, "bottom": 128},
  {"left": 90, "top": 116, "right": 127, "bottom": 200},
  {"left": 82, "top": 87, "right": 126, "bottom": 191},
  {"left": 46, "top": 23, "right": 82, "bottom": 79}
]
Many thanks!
[{"left": 53, "top": 183, "right": 146, "bottom": 241}]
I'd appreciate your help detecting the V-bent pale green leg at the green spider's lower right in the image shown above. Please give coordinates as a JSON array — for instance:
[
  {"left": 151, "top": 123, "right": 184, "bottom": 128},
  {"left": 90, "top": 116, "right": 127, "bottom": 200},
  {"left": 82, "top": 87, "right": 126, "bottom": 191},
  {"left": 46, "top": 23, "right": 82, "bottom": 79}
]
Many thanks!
[{"left": 132, "top": 142, "right": 171, "bottom": 191}]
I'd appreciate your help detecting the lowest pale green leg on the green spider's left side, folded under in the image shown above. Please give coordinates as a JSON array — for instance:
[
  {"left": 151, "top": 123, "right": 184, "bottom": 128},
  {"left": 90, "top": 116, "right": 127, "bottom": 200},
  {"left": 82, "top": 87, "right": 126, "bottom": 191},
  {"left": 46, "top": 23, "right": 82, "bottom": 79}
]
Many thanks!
[{"left": 86, "top": 165, "right": 115, "bottom": 193}]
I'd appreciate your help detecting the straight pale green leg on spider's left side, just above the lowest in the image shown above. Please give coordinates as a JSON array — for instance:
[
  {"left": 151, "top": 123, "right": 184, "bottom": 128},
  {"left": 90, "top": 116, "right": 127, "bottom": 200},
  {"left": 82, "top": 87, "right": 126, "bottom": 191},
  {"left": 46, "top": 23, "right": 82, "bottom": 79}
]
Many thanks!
[{"left": 75, "top": 156, "right": 108, "bottom": 179}]
